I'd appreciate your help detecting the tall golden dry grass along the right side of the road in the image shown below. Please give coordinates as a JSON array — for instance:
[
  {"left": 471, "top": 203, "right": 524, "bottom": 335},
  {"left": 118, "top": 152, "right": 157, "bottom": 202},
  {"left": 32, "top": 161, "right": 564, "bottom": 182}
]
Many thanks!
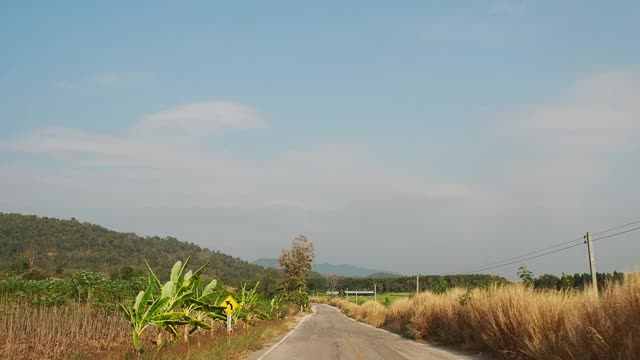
[{"left": 332, "top": 274, "right": 640, "bottom": 360}]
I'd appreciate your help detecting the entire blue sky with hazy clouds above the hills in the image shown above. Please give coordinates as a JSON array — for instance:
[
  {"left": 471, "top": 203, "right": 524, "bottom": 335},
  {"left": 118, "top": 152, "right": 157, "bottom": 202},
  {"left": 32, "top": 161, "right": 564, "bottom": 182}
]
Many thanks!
[{"left": 0, "top": 0, "right": 640, "bottom": 277}]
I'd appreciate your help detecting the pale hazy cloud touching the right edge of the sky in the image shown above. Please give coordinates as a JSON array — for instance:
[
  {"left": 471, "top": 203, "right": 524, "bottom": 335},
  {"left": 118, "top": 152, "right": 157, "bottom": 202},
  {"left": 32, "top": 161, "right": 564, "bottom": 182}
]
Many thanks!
[{"left": 509, "top": 72, "right": 640, "bottom": 154}]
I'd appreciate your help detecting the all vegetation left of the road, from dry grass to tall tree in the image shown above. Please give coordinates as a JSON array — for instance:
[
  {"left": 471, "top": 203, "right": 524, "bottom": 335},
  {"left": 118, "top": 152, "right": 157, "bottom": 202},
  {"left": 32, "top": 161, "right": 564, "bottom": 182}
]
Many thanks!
[{"left": 0, "top": 229, "right": 313, "bottom": 359}]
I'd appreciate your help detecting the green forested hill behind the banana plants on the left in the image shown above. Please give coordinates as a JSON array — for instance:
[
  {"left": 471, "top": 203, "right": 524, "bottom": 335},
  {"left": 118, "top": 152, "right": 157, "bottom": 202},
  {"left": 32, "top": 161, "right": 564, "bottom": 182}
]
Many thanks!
[{"left": 0, "top": 213, "right": 264, "bottom": 285}]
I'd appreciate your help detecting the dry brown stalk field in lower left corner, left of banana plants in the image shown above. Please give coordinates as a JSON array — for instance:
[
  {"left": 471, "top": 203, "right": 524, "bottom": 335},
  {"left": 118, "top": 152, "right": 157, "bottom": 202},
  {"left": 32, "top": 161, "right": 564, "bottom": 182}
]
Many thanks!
[{"left": 0, "top": 300, "right": 131, "bottom": 359}]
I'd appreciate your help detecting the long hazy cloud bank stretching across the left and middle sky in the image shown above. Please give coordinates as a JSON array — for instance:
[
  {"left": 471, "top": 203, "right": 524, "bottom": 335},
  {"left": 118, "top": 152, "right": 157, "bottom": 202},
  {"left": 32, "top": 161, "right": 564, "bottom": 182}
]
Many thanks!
[{"left": 0, "top": 101, "right": 473, "bottom": 215}]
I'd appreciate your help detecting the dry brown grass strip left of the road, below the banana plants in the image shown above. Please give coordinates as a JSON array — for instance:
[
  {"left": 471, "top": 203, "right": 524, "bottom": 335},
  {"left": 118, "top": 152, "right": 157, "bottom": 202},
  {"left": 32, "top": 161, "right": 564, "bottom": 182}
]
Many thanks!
[{"left": 0, "top": 300, "right": 304, "bottom": 359}]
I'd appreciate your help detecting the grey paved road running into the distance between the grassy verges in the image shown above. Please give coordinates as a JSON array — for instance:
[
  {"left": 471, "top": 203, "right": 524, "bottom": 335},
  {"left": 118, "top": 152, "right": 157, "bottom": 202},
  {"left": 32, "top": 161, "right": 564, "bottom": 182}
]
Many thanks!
[{"left": 249, "top": 305, "right": 477, "bottom": 360}]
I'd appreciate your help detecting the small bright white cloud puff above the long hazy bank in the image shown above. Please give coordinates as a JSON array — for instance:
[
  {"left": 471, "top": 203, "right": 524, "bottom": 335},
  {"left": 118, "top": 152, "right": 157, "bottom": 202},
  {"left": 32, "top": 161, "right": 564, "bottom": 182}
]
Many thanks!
[{"left": 137, "top": 101, "right": 266, "bottom": 136}]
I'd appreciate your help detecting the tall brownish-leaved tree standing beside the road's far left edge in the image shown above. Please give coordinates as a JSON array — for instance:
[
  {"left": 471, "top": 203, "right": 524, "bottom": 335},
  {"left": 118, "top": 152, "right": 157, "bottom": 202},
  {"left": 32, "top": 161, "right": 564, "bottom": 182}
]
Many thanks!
[{"left": 278, "top": 235, "right": 315, "bottom": 307}]
